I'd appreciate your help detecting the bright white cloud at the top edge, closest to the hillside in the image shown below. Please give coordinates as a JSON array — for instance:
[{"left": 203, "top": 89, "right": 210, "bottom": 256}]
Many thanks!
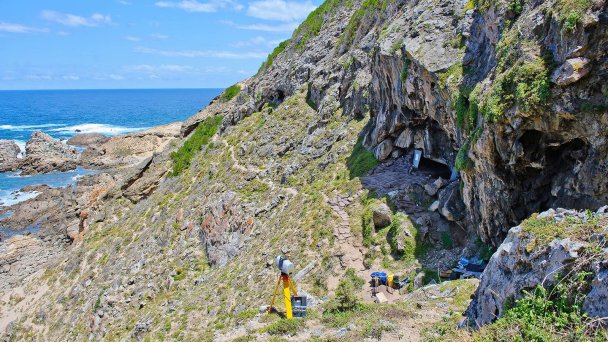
[{"left": 247, "top": 0, "right": 316, "bottom": 22}]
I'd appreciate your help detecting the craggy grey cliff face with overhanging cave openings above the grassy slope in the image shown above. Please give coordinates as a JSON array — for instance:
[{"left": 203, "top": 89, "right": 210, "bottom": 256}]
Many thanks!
[{"left": 225, "top": 0, "right": 608, "bottom": 245}]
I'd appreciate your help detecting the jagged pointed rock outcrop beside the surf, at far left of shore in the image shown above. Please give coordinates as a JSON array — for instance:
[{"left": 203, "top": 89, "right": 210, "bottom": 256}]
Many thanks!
[{"left": 20, "top": 131, "right": 78, "bottom": 175}]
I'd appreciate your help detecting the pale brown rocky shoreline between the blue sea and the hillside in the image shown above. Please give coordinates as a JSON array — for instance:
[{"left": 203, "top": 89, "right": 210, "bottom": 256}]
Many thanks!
[{"left": 0, "top": 122, "right": 181, "bottom": 288}]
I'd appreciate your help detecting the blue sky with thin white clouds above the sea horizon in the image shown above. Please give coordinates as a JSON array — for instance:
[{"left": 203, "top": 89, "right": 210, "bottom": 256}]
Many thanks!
[{"left": 0, "top": 0, "right": 322, "bottom": 90}]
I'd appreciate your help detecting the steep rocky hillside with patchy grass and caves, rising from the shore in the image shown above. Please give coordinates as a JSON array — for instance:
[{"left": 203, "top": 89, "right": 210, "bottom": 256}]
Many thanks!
[{"left": 0, "top": 0, "right": 608, "bottom": 340}]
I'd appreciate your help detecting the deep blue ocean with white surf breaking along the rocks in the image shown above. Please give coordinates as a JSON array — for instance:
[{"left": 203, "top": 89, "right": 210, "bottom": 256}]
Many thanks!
[{"left": 0, "top": 89, "right": 222, "bottom": 206}]
